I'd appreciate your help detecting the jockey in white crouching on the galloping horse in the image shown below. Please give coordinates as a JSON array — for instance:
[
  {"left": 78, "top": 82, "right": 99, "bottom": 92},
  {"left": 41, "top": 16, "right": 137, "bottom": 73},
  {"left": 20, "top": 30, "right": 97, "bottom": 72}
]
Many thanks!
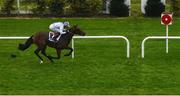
[{"left": 49, "top": 22, "right": 70, "bottom": 41}]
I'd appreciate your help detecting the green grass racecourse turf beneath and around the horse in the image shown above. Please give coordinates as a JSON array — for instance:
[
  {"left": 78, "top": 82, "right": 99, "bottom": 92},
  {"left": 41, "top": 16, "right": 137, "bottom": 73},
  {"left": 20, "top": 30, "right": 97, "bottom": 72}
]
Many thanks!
[{"left": 0, "top": 18, "right": 180, "bottom": 95}]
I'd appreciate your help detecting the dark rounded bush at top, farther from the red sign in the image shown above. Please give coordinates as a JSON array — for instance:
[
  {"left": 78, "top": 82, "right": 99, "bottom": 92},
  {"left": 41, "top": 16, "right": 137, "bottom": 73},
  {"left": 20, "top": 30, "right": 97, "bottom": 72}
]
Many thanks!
[{"left": 110, "top": 0, "right": 129, "bottom": 17}]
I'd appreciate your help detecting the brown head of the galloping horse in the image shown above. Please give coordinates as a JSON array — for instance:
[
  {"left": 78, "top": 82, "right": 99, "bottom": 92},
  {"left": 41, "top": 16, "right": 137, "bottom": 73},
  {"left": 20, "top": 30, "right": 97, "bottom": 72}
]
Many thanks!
[{"left": 70, "top": 25, "right": 86, "bottom": 36}]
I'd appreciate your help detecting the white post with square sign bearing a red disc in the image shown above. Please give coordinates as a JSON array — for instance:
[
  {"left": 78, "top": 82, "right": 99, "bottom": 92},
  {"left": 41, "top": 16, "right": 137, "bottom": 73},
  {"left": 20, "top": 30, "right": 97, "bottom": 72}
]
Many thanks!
[{"left": 161, "top": 12, "right": 173, "bottom": 53}]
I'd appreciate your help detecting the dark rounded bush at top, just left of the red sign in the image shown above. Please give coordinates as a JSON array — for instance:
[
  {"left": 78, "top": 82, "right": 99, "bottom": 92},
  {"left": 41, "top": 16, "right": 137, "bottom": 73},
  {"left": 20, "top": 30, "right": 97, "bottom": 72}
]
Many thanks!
[{"left": 145, "top": 0, "right": 165, "bottom": 17}]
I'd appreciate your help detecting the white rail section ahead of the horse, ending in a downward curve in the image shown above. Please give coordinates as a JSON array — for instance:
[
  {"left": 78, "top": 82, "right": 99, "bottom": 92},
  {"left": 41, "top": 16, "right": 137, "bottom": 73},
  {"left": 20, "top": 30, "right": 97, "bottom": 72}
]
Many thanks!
[{"left": 72, "top": 36, "right": 130, "bottom": 58}]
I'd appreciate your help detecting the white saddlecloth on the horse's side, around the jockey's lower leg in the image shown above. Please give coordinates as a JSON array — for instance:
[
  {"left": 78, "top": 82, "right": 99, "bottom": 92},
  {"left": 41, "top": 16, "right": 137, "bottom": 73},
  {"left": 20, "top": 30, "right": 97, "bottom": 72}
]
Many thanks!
[{"left": 49, "top": 32, "right": 61, "bottom": 42}]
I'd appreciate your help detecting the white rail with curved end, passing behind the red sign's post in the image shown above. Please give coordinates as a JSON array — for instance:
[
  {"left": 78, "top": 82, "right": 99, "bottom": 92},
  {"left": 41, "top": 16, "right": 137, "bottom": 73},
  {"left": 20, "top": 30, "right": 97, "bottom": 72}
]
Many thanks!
[{"left": 141, "top": 36, "right": 180, "bottom": 58}]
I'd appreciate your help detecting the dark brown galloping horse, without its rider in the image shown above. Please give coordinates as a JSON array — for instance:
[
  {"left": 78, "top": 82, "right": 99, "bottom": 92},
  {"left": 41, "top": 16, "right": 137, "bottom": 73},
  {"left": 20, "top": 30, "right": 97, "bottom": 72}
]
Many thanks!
[{"left": 18, "top": 25, "right": 85, "bottom": 63}]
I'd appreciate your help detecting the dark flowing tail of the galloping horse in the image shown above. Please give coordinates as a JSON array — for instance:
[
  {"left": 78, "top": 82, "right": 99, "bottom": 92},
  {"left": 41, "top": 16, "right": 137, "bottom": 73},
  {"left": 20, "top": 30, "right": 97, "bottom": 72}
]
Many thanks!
[{"left": 18, "top": 36, "right": 33, "bottom": 51}]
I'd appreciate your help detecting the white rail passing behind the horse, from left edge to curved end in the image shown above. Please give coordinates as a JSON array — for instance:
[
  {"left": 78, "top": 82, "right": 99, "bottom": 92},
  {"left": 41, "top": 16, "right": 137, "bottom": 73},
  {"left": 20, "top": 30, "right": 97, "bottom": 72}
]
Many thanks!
[{"left": 0, "top": 36, "right": 130, "bottom": 58}]
